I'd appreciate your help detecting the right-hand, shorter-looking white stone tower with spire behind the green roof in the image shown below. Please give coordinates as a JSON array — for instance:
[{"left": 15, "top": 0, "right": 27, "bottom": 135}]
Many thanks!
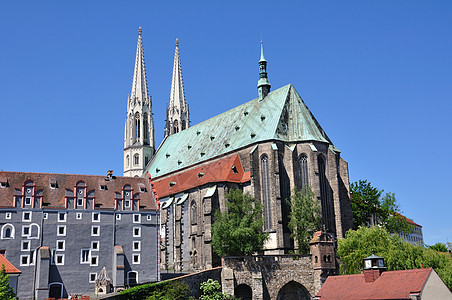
[{"left": 165, "top": 39, "right": 190, "bottom": 137}]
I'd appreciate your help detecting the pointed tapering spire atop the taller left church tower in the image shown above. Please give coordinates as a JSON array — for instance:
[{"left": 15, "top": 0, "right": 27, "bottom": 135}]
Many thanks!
[{"left": 130, "top": 27, "right": 149, "bottom": 102}]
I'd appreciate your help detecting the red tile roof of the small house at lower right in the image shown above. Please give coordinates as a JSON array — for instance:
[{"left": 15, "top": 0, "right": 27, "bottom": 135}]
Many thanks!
[{"left": 316, "top": 268, "right": 432, "bottom": 300}]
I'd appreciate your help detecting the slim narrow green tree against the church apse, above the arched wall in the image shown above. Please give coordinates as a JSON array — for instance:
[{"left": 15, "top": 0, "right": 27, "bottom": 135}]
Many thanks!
[{"left": 289, "top": 186, "right": 322, "bottom": 254}]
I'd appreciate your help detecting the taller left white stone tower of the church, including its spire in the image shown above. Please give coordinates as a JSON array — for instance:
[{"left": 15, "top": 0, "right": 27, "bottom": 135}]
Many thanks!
[{"left": 124, "top": 27, "right": 155, "bottom": 177}]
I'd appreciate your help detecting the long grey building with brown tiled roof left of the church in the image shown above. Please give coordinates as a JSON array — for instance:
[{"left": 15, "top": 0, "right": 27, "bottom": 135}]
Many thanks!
[{"left": 0, "top": 171, "right": 160, "bottom": 299}]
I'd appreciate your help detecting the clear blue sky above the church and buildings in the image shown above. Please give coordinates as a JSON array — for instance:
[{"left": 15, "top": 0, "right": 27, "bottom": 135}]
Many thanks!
[{"left": 0, "top": 0, "right": 452, "bottom": 244}]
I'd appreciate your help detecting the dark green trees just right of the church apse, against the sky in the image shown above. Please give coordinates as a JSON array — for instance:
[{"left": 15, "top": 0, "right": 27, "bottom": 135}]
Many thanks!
[{"left": 350, "top": 180, "right": 412, "bottom": 233}]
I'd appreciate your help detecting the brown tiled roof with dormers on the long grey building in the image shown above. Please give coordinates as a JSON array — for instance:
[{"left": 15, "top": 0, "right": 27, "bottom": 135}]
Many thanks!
[{"left": 0, "top": 171, "right": 157, "bottom": 210}]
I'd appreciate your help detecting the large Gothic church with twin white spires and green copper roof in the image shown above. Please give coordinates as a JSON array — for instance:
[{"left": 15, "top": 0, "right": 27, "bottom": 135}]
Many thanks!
[{"left": 124, "top": 29, "right": 352, "bottom": 273}]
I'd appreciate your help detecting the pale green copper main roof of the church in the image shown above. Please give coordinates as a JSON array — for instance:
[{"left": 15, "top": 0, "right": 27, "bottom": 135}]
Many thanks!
[{"left": 146, "top": 84, "right": 338, "bottom": 178}]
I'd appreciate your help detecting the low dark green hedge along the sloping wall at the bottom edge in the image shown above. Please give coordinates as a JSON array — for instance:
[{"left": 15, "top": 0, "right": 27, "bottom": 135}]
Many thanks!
[{"left": 121, "top": 281, "right": 189, "bottom": 300}]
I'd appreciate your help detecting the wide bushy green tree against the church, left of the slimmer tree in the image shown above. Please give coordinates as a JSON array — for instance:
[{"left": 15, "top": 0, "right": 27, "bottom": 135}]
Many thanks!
[{"left": 212, "top": 190, "right": 268, "bottom": 256}]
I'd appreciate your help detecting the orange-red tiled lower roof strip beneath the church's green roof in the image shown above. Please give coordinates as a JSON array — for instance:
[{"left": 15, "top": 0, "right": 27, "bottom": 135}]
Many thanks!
[{"left": 152, "top": 154, "right": 251, "bottom": 198}]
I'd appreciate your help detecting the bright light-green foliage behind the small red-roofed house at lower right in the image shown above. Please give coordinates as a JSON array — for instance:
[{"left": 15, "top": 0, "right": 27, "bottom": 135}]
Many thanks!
[{"left": 337, "top": 226, "right": 452, "bottom": 289}]
